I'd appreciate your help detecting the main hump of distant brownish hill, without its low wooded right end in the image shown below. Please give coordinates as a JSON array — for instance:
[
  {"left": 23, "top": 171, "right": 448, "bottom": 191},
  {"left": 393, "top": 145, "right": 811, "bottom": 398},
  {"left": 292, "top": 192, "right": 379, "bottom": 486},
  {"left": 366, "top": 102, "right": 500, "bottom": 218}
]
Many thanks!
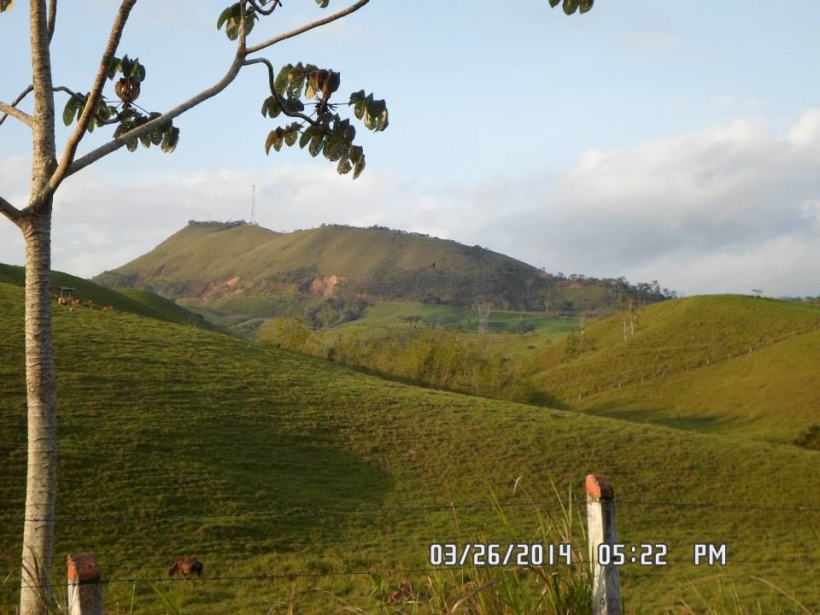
[{"left": 98, "top": 223, "right": 546, "bottom": 303}]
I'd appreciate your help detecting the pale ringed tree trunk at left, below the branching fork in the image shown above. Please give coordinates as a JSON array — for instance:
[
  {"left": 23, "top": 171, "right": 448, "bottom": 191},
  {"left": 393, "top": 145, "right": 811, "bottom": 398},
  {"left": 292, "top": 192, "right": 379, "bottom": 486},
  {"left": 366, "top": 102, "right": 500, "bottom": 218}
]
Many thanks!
[{"left": 20, "top": 208, "right": 57, "bottom": 615}]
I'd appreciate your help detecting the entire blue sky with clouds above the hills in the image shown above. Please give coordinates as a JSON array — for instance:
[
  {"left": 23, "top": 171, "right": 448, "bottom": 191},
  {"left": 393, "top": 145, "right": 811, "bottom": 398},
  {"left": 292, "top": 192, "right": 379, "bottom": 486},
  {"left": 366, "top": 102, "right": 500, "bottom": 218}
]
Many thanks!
[{"left": 0, "top": 0, "right": 820, "bottom": 296}]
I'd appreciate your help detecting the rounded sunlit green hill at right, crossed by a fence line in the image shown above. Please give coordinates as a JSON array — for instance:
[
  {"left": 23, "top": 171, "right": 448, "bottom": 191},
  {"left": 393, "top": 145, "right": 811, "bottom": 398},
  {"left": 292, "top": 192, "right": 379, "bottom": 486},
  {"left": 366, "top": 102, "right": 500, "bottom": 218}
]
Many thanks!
[{"left": 528, "top": 296, "right": 820, "bottom": 442}]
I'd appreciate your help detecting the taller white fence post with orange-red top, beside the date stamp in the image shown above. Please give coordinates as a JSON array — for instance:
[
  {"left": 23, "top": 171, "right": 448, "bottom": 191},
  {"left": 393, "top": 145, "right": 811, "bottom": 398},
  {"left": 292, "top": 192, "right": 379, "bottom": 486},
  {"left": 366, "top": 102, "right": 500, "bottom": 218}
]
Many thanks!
[{"left": 586, "top": 474, "right": 621, "bottom": 615}]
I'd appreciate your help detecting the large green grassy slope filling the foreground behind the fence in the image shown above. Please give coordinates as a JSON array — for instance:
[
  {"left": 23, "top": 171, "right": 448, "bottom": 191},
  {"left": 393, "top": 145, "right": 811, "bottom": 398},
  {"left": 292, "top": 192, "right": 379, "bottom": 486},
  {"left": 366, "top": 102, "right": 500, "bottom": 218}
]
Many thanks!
[{"left": 0, "top": 283, "right": 820, "bottom": 615}]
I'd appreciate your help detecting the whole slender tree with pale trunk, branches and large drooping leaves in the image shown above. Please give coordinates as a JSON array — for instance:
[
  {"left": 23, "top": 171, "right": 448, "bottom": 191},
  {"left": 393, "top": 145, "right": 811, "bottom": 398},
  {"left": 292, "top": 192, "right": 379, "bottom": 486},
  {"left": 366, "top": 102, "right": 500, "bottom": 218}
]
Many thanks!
[{"left": 0, "top": 0, "right": 593, "bottom": 615}]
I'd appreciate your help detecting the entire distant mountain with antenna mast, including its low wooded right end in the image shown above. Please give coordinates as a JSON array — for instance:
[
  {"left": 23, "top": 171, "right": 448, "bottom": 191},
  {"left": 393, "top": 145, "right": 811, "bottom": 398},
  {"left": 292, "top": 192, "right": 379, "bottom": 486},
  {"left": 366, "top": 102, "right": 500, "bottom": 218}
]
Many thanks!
[{"left": 95, "top": 221, "right": 663, "bottom": 316}]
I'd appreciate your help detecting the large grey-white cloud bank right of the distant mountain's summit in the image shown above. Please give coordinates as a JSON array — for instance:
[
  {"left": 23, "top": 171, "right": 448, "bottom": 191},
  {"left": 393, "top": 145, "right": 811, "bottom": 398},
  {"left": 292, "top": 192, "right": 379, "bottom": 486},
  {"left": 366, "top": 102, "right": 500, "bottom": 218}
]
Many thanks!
[{"left": 462, "top": 110, "right": 820, "bottom": 294}]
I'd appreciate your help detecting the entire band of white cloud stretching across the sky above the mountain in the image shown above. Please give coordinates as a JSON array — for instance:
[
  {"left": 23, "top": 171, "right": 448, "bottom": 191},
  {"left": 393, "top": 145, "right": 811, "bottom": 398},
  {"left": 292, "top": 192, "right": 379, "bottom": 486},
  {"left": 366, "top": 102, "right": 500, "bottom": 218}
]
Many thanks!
[{"left": 0, "top": 109, "right": 820, "bottom": 295}]
